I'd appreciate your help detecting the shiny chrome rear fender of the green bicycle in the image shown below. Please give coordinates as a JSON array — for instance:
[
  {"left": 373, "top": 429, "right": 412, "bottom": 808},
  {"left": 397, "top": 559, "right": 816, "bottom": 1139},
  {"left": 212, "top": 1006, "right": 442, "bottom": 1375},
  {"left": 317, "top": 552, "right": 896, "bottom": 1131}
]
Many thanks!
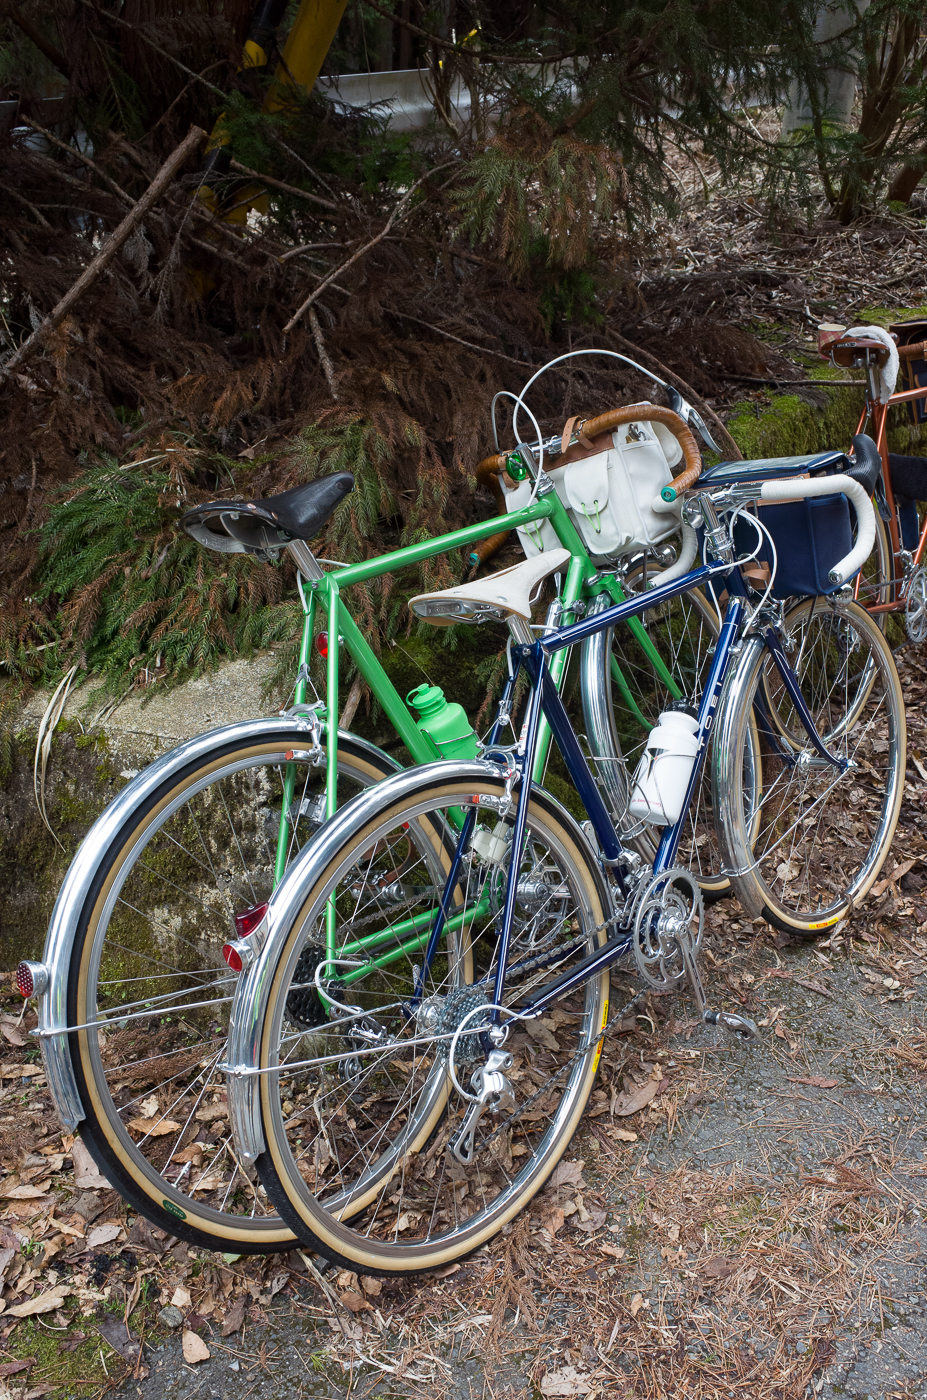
[{"left": 36, "top": 715, "right": 399, "bottom": 1133}]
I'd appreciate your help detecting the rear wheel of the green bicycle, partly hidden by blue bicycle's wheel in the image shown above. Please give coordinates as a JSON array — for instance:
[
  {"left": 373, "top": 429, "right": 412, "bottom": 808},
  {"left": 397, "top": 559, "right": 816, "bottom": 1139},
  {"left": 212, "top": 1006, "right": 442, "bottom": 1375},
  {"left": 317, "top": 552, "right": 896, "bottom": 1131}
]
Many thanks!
[{"left": 67, "top": 721, "right": 396, "bottom": 1253}]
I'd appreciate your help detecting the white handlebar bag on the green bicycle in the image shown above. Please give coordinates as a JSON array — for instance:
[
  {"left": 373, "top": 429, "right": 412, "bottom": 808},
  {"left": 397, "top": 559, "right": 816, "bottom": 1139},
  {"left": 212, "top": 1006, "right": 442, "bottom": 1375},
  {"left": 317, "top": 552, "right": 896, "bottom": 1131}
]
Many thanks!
[{"left": 506, "top": 423, "right": 679, "bottom": 564}]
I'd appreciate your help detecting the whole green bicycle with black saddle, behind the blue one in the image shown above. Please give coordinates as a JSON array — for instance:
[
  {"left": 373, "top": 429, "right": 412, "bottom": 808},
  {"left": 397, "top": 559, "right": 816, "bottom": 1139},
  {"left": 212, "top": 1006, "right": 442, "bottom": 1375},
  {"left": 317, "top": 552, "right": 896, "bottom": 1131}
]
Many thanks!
[{"left": 21, "top": 378, "right": 739, "bottom": 1253}]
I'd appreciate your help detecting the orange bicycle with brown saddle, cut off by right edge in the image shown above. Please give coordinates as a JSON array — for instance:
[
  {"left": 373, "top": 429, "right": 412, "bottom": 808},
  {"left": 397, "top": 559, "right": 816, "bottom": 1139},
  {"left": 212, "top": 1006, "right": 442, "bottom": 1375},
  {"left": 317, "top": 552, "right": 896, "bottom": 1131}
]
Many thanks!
[{"left": 819, "top": 321, "right": 927, "bottom": 643}]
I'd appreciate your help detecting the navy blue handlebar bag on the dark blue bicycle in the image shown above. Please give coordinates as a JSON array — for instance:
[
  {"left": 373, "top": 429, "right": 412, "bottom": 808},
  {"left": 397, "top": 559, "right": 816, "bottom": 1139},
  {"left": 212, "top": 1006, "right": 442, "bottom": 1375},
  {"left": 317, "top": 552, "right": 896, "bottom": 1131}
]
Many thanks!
[{"left": 734, "top": 493, "right": 853, "bottom": 599}]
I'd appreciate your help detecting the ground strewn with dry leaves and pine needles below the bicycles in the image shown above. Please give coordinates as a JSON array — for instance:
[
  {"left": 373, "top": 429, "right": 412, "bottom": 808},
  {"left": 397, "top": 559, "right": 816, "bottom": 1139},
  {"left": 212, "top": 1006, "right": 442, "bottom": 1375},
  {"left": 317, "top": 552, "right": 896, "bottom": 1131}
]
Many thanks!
[{"left": 0, "top": 648, "right": 927, "bottom": 1400}]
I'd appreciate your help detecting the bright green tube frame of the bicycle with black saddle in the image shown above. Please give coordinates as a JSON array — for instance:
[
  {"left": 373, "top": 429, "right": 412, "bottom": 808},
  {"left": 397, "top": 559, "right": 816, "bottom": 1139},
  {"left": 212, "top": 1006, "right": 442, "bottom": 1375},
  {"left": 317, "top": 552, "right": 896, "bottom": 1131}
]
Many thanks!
[{"left": 274, "top": 470, "right": 682, "bottom": 983}]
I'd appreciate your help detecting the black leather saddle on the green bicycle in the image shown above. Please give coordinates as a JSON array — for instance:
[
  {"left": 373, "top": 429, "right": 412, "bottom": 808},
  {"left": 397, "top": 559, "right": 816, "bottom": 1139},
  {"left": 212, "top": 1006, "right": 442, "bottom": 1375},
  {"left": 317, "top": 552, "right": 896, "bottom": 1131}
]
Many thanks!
[{"left": 181, "top": 472, "right": 354, "bottom": 554}]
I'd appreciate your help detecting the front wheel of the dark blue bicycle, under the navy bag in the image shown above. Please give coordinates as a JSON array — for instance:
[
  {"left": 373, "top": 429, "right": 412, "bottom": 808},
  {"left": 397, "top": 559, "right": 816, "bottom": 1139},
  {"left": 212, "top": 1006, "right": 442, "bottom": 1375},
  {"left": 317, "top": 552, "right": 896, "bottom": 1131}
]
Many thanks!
[{"left": 714, "top": 598, "right": 905, "bottom": 938}]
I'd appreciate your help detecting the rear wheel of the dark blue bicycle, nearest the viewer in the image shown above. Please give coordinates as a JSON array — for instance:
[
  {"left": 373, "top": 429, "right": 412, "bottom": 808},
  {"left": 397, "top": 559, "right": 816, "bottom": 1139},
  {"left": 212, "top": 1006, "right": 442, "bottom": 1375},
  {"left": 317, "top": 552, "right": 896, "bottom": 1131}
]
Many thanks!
[{"left": 258, "top": 764, "right": 608, "bottom": 1274}]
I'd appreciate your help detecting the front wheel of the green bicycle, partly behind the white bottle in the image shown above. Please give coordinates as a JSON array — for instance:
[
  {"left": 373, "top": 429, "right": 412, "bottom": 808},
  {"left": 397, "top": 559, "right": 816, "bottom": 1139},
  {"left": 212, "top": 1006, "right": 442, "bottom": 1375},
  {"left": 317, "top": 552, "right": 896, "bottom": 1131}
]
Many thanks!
[{"left": 583, "top": 570, "right": 759, "bottom": 899}]
